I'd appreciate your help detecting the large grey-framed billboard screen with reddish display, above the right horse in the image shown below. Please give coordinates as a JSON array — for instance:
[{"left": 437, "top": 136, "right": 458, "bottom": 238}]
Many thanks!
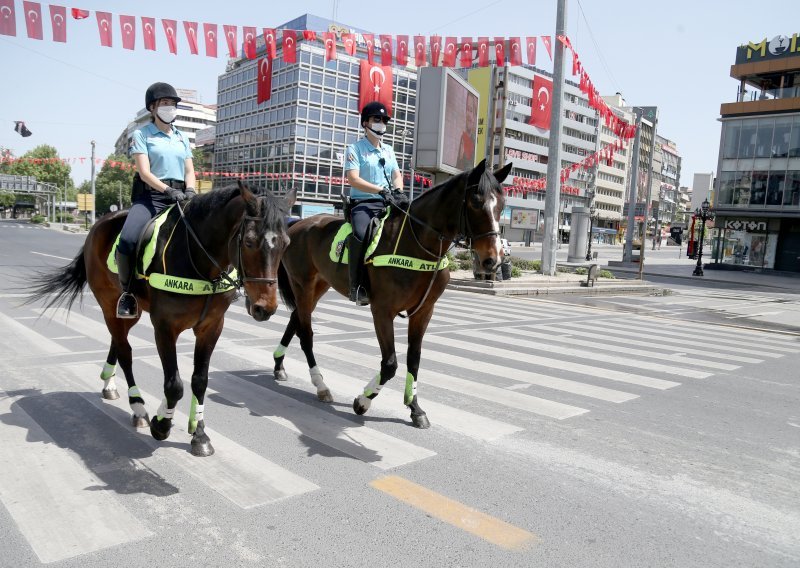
[{"left": 414, "top": 67, "right": 480, "bottom": 175}]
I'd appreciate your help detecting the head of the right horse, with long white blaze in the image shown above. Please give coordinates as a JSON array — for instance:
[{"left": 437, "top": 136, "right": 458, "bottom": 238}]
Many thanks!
[{"left": 461, "top": 160, "right": 511, "bottom": 274}]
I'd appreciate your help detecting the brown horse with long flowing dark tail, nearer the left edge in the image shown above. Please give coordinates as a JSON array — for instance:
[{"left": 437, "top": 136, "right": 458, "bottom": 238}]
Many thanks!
[{"left": 28, "top": 182, "right": 295, "bottom": 456}]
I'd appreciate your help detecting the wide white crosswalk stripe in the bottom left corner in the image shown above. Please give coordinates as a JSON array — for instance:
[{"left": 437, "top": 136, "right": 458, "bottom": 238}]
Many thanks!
[{"left": 0, "top": 393, "right": 152, "bottom": 563}]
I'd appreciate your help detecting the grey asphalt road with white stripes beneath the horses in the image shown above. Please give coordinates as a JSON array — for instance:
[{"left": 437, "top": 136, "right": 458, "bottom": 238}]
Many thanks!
[{"left": 0, "top": 221, "right": 800, "bottom": 568}]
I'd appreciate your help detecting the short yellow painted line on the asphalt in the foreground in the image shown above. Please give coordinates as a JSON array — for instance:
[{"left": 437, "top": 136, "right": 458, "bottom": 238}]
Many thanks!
[{"left": 370, "top": 475, "right": 539, "bottom": 550}]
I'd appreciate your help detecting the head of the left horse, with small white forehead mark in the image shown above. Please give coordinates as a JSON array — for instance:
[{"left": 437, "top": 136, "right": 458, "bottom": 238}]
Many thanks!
[{"left": 236, "top": 181, "right": 296, "bottom": 321}]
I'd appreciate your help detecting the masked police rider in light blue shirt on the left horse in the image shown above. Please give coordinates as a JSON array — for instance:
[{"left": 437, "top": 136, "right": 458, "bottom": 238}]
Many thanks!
[{"left": 116, "top": 83, "right": 196, "bottom": 318}]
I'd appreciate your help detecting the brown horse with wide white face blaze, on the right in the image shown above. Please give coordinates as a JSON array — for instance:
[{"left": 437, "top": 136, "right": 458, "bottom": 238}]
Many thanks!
[{"left": 274, "top": 161, "right": 511, "bottom": 428}]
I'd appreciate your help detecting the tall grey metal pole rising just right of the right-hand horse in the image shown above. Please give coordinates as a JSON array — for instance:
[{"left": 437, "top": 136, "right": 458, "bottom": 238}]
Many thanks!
[{"left": 542, "top": 0, "right": 567, "bottom": 276}]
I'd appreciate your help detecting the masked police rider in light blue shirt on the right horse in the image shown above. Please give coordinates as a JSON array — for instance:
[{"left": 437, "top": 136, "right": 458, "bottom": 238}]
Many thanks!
[{"left": 345, "top": 102, "right": 408, "bottom": 306}]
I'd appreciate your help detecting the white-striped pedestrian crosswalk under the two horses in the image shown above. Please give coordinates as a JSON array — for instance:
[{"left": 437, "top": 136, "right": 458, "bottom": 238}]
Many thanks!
[{"left": 0, "top": 292, "right": 800, "bottom": 563}]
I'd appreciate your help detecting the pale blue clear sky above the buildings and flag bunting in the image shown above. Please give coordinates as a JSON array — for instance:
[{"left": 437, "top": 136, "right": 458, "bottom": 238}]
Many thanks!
[{"left": 0, "top": 0, "right": 800, "bottom": 186}]
